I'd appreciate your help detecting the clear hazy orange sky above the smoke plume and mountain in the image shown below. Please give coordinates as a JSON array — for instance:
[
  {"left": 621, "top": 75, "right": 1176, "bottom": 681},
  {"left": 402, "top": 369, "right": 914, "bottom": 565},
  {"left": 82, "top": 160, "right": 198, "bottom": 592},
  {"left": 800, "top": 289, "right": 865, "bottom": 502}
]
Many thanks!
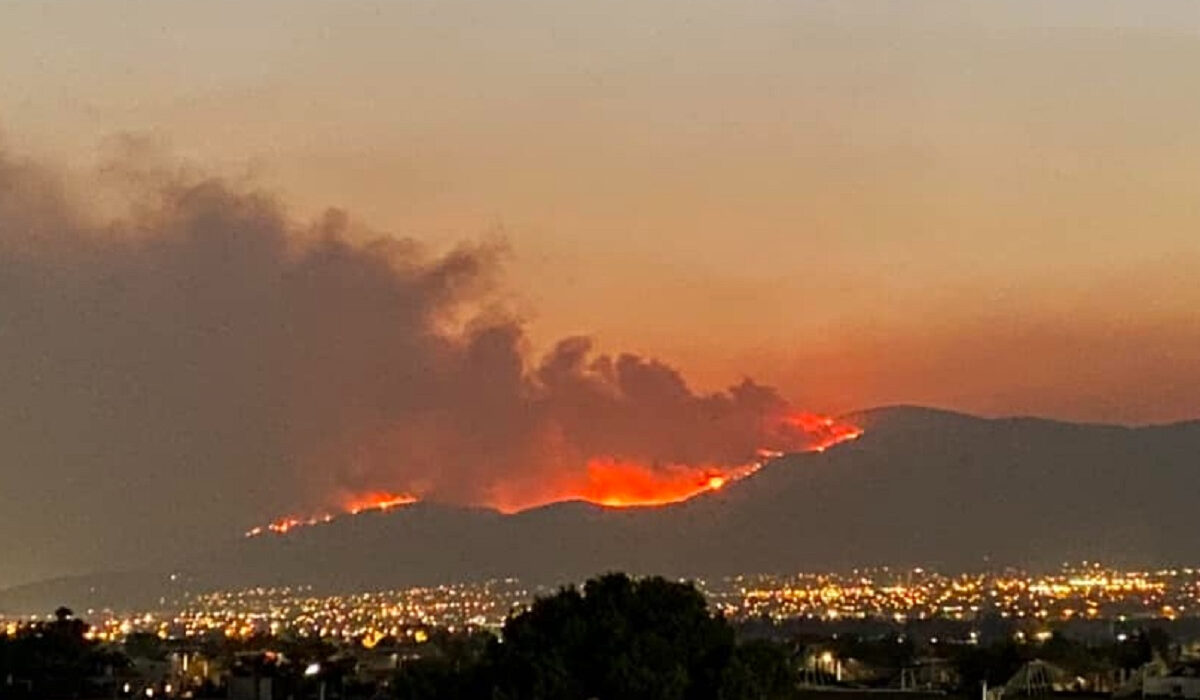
[{"left": 0, "top": 0, "right": 1200, "bottom": 421}]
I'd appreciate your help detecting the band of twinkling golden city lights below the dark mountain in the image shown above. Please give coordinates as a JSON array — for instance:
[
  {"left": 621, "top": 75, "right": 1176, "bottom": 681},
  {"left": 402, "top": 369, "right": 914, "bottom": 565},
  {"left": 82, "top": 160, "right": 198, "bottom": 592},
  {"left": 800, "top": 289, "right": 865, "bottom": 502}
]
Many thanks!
[{"left": 9, "top": 563, "right": 1200, "bottom": 647}]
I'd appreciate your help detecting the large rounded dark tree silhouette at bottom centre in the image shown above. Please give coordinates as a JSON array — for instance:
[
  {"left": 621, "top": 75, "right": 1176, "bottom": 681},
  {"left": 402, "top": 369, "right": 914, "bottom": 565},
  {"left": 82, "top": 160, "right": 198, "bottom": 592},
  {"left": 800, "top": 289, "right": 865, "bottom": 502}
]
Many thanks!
[{"left": 392, "top": 574, "right": 796, "bottom": 700}]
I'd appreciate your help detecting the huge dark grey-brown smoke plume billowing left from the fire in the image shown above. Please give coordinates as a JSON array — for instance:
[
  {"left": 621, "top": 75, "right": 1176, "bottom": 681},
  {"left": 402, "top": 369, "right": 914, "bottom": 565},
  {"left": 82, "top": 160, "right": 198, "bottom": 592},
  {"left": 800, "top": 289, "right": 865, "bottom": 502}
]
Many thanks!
[{"left": 0, "top": 142, "right": 816, "bottom": 584}]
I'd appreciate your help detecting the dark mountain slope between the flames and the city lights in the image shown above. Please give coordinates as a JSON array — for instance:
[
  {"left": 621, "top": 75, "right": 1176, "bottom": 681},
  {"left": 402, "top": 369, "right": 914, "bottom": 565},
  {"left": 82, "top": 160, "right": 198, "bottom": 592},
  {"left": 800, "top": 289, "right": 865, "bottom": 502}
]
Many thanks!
[{"left": 0, "top": 407, "right": 1200, "bottom": 610}]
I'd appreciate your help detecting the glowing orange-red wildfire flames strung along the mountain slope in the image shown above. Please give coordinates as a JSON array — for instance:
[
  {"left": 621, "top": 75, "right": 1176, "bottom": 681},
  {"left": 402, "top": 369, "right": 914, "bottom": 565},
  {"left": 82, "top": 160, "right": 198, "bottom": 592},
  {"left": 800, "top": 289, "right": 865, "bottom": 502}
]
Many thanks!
[{"left": 245, "top": 413, "right": 863, "bottom": 537}]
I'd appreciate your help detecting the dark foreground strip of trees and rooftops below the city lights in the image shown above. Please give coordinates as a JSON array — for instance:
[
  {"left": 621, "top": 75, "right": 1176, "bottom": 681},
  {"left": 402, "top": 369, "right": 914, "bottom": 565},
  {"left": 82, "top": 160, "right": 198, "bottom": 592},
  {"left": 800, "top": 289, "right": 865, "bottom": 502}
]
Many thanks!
[{"left": 0, "top": 574, "right": 1200, "bottom": 700}]
